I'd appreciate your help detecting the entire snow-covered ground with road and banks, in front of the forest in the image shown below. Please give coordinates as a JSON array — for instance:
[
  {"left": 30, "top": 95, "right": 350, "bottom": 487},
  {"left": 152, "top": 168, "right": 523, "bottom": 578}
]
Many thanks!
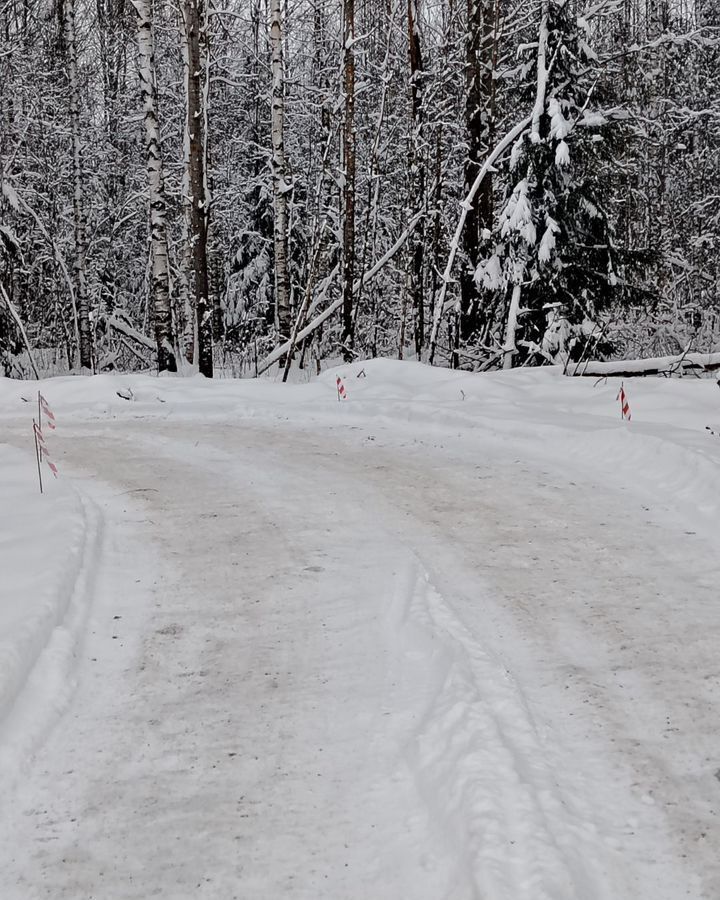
[{"left": 0, "top": 360, "right": 720, "bottom": 900}]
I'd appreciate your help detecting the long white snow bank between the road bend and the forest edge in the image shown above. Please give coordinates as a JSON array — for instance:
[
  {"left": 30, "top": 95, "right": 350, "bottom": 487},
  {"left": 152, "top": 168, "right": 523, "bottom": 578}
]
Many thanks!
[{"left": 0, "top": 359, "right": 720, "bottom": 540}]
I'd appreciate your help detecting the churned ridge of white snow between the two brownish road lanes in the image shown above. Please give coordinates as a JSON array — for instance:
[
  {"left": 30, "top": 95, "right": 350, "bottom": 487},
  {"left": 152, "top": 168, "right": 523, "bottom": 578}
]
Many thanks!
[{"left": 388, "top": 560, "right": 614, "bottom": 900}]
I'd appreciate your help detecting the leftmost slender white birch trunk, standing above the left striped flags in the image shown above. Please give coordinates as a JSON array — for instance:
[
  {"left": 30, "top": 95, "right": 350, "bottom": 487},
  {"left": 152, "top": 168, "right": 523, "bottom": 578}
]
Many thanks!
[{"left": 64, "top": 0, "right": 93, "bottom": 371}]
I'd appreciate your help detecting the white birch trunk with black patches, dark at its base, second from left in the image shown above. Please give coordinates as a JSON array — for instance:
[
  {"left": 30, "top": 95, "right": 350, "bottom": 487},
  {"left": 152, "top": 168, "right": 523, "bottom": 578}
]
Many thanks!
[{"left": 133, "top": 0, "right": 177, "bottom": 372}]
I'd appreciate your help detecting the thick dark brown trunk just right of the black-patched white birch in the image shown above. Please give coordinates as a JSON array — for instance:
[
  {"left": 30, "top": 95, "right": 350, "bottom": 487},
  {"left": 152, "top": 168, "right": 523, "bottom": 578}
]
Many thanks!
[{"left": 182, "top": 0, "right": 213, "bottom": 378}]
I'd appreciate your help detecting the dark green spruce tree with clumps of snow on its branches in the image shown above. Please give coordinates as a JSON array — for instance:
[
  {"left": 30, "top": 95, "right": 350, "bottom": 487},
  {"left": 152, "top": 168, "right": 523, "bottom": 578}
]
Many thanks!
[{"left": 475, "top": 0, "right": 617, "bottom": 368}]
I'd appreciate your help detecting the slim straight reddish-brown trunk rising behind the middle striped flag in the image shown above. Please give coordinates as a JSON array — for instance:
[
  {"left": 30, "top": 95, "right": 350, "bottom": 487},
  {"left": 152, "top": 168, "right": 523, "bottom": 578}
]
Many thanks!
[{"left": 342, "top": 0, "right": 355, "bottom": 361}]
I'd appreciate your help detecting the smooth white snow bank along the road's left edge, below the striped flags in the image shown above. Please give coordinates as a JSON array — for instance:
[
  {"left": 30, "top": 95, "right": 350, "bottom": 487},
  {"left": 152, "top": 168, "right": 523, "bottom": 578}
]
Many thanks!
[{"left": 0, "top": 442, "right": 98, "bottom": 780}]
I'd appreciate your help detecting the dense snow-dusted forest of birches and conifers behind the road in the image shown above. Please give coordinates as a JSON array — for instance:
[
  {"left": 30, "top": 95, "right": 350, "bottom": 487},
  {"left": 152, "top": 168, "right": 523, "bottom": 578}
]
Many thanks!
[{"left": 0, "top": 0, "right": 720, "bottom": 376}]
